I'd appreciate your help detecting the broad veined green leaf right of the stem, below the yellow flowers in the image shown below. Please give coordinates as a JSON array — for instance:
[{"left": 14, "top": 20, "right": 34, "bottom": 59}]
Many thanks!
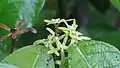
[{"left": 68, "top": 40, "right": 120, "bottom": 68}]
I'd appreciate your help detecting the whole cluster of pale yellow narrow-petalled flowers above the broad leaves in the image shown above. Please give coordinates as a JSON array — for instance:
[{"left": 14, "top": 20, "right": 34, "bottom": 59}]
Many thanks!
[{"left": 33, "top": 18, "right": 90, "bottom": 56}]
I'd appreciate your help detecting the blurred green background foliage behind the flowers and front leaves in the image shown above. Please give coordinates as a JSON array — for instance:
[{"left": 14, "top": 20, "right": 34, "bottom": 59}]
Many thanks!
[{"left": 0, "top": 0, "right": 120, "bottom": 62}]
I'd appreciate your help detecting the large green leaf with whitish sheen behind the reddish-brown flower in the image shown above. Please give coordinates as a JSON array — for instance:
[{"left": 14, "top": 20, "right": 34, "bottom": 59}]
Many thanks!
[{"left": 0, "top": 0, "right": 45, "bottom": 27}]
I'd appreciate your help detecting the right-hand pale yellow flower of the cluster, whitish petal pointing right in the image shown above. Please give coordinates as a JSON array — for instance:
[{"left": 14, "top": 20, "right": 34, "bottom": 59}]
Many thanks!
[{"left": 58, "top": 19, "right": 90, "bottom": 42}]
